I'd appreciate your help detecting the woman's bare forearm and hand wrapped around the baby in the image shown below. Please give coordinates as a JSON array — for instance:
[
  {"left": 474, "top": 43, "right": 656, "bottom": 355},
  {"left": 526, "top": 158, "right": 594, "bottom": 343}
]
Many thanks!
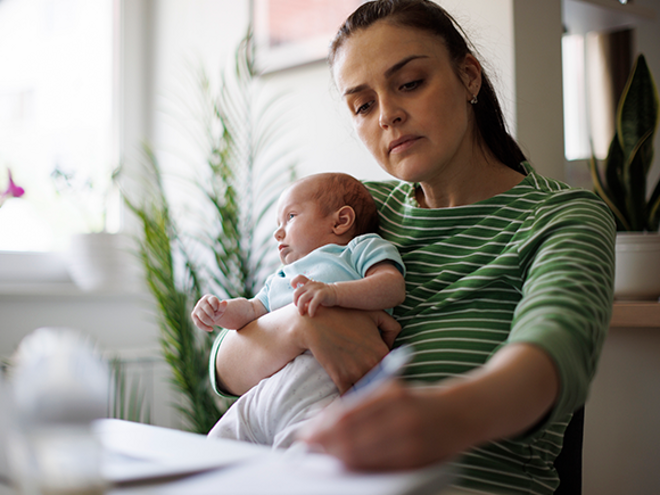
[{"left": 215, "top": 304, "right": 400, "bottom": 395}]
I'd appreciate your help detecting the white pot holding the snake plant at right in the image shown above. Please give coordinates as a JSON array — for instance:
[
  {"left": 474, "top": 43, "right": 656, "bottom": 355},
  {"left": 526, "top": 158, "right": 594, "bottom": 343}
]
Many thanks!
[{"left": 614, "top": 232, "right": 660, "bottom": 301}]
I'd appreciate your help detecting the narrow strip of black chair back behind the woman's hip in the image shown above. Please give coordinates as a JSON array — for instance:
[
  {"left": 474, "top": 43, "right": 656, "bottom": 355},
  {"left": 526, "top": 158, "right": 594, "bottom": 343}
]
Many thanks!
[{"left": 555, "top": 406, "right": 584, "bottom": 495}]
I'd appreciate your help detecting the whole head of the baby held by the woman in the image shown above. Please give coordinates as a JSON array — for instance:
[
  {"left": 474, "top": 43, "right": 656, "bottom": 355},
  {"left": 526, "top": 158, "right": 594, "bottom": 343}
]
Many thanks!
[{"left": 275, "top": 173, "right": 378, "bottom": 265}]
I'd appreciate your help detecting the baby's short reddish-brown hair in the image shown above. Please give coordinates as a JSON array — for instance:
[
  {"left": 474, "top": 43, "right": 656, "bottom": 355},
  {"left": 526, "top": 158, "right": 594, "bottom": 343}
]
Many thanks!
[{"left": 302, "top": 173, "right": 378, "bottom": 236}]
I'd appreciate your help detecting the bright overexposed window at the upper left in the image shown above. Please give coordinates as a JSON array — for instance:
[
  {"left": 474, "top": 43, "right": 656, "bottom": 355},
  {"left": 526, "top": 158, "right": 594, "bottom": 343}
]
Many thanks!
[{"left": 0, "top": 0, "right": 117, "bottom": 251}]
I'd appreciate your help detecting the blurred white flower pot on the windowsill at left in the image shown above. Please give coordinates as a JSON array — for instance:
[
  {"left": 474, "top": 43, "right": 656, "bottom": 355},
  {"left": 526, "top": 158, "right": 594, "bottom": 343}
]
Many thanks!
[{"left": 66, "top": 232, "right": 143, "bottom": 292}]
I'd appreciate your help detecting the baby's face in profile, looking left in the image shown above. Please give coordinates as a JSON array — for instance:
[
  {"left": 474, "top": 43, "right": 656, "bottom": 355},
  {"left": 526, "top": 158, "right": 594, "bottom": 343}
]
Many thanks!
[{"left": 274, "top": 182, "right": 336, "bottom": 265}]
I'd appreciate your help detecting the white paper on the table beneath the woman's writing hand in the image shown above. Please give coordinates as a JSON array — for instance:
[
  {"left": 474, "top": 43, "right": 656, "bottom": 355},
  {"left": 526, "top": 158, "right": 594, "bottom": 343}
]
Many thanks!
[{"left": 95, "top": 420, "right": 453, "bottom": 495}]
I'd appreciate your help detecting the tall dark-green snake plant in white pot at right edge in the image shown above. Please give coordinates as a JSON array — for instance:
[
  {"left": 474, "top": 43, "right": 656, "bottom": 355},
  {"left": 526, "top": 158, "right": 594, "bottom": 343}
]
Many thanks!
[{"left": 590, "top": 55, "right": 660, "bottom": 300}]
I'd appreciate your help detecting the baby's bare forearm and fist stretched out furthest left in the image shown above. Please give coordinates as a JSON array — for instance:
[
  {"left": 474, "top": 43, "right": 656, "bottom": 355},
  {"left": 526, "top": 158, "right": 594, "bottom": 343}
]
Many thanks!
[{"left": 190, "top": 294, "right": 267, "bottom": 332}]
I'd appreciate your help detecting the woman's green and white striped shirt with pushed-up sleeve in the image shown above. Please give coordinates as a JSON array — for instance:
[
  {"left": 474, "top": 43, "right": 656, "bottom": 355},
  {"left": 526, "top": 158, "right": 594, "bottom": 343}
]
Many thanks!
[{"left": 366, "top": 168, "right": 615, "bottom": 494}]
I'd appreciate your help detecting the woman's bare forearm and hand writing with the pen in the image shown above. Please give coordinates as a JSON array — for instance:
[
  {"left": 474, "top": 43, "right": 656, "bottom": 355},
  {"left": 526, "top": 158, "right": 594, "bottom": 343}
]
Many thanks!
[{"left": 302, "top": 343, "right": 559, "bottom": 470}]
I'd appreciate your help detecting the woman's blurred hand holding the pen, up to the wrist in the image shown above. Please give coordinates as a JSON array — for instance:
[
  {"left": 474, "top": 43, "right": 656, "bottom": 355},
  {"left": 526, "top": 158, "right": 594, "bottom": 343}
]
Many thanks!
[{"left": 301, "top": 380, "right": 465, "bottom": 470}]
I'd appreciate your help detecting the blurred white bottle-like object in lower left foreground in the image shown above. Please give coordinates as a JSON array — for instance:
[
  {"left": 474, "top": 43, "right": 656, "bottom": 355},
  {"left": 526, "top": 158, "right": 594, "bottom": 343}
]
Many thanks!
[{"left": 7, "top": 328, "right": 110, "bottom": 495}]
